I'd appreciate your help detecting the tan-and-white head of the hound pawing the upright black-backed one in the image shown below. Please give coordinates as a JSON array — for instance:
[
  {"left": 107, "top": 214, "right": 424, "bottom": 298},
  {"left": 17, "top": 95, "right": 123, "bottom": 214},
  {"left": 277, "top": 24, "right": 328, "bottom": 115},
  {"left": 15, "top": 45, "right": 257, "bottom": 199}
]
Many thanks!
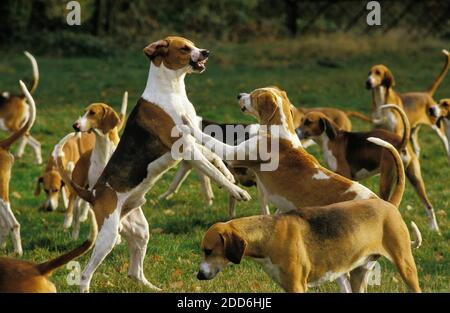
[{"left": 237, "top": 86, "right": 294, "bottom": 132}]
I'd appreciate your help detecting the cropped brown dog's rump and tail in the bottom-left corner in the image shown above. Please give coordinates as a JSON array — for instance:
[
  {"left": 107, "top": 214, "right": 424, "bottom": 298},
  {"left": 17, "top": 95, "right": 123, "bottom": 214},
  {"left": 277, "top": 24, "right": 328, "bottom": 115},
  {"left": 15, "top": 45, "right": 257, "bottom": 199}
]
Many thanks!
[{"left": 0, "top": 208, "right": 97, "bottom": 293}]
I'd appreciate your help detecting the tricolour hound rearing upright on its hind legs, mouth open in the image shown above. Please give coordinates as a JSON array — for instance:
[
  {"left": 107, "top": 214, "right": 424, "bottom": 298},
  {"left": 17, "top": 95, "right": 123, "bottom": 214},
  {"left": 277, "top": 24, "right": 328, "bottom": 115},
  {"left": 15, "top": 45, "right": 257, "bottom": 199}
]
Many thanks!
[{"left": 58, "top": 36, "right": 250, "bottom": 292}]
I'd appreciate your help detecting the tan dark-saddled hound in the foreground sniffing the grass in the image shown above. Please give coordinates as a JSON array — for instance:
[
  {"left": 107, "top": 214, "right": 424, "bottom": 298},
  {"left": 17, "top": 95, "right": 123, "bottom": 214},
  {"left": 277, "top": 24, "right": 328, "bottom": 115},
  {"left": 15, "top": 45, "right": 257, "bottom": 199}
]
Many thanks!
[{"left": 197, "top": 199, "right": 421, "bottom": 292}]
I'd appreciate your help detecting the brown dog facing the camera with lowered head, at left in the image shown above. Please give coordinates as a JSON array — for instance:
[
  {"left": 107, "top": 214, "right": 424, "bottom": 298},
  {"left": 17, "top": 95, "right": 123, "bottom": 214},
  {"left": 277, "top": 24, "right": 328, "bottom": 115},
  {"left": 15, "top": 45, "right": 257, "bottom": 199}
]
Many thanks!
[{"left": 34, "top": 130, "right": 95, "bottom": 211}]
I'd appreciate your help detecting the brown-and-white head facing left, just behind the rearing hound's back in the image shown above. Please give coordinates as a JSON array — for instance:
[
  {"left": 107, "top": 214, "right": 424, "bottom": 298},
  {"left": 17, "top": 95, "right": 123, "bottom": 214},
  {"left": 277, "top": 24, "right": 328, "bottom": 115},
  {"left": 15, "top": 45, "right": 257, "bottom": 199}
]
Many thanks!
[{"left": 73, "top": 103, "right": 120, "bottom": 134}]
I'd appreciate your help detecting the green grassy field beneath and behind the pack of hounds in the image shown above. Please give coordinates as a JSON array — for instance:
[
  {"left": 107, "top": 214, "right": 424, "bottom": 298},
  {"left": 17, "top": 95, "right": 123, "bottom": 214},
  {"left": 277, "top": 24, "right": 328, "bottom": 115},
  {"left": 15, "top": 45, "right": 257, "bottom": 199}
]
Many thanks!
[{"left": 0, "top": 35, "right": 450, "bottom": 292}]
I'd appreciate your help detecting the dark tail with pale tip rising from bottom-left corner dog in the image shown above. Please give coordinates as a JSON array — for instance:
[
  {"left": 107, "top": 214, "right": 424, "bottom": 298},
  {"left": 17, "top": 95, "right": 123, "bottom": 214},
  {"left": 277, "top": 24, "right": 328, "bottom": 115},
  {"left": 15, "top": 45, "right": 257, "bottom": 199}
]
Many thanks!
[{"left": 37, "top": 210, "right": 98, "bottom": 275}]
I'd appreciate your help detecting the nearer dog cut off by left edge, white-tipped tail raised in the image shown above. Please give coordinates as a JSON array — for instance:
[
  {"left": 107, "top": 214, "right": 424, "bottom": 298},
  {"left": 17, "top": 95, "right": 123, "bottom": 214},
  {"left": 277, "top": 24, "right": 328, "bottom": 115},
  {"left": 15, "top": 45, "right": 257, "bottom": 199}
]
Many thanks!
[{"left": 0, "top": 81, "right": 36, "bottom": 256}]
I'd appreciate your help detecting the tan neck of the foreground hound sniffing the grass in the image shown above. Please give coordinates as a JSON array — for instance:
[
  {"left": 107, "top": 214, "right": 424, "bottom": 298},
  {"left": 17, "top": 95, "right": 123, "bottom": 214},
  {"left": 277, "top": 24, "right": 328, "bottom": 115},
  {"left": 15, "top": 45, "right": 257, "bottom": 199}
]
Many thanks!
[{"left": 232, "top": 215, "right": 275, "bottom": 258}]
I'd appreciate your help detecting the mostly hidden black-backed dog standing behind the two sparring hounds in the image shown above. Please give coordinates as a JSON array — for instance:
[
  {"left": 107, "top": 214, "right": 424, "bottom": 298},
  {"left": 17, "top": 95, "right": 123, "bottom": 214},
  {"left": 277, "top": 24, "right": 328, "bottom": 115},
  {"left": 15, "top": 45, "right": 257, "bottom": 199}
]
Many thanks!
[{"left": 159, "top": 119, "right": 264, "bottom": 218}]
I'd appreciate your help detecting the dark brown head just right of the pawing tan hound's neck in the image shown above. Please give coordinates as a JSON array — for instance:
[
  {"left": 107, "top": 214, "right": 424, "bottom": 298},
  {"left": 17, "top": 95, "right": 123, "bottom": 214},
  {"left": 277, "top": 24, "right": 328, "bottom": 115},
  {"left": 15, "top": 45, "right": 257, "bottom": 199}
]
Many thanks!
[{"left": 296, "top": 112, "right": 336, "bottom": 140}]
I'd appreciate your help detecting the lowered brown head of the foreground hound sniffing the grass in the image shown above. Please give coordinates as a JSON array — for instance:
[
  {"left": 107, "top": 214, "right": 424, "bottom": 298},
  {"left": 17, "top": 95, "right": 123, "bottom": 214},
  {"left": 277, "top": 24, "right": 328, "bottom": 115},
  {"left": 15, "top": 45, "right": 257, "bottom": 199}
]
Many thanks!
[{"left": 197, "top": 223, "right": 247, "bottom": 280}]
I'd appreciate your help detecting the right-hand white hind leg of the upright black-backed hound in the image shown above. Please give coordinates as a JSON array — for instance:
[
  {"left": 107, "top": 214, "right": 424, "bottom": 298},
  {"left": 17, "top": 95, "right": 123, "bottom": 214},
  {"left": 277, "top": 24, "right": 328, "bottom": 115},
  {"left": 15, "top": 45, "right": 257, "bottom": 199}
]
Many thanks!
[{"left": 121, "top": 207, "right": 161, "bottom": 291}]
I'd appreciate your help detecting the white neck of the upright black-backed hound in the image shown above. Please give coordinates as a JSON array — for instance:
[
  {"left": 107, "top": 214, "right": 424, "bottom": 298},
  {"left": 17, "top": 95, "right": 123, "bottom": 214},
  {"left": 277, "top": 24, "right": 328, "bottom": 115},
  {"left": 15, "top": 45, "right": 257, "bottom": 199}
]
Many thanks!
[{"left": 142, "top": 62, "right": 187, "bottom": 103}]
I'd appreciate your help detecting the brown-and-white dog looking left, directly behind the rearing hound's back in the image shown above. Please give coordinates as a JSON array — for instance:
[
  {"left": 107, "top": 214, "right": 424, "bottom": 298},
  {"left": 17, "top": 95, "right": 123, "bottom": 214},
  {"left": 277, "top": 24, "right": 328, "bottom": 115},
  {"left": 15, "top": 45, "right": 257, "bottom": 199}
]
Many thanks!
[{"left": 59, "top": 92, "right": 128, "bottom": 239}]
